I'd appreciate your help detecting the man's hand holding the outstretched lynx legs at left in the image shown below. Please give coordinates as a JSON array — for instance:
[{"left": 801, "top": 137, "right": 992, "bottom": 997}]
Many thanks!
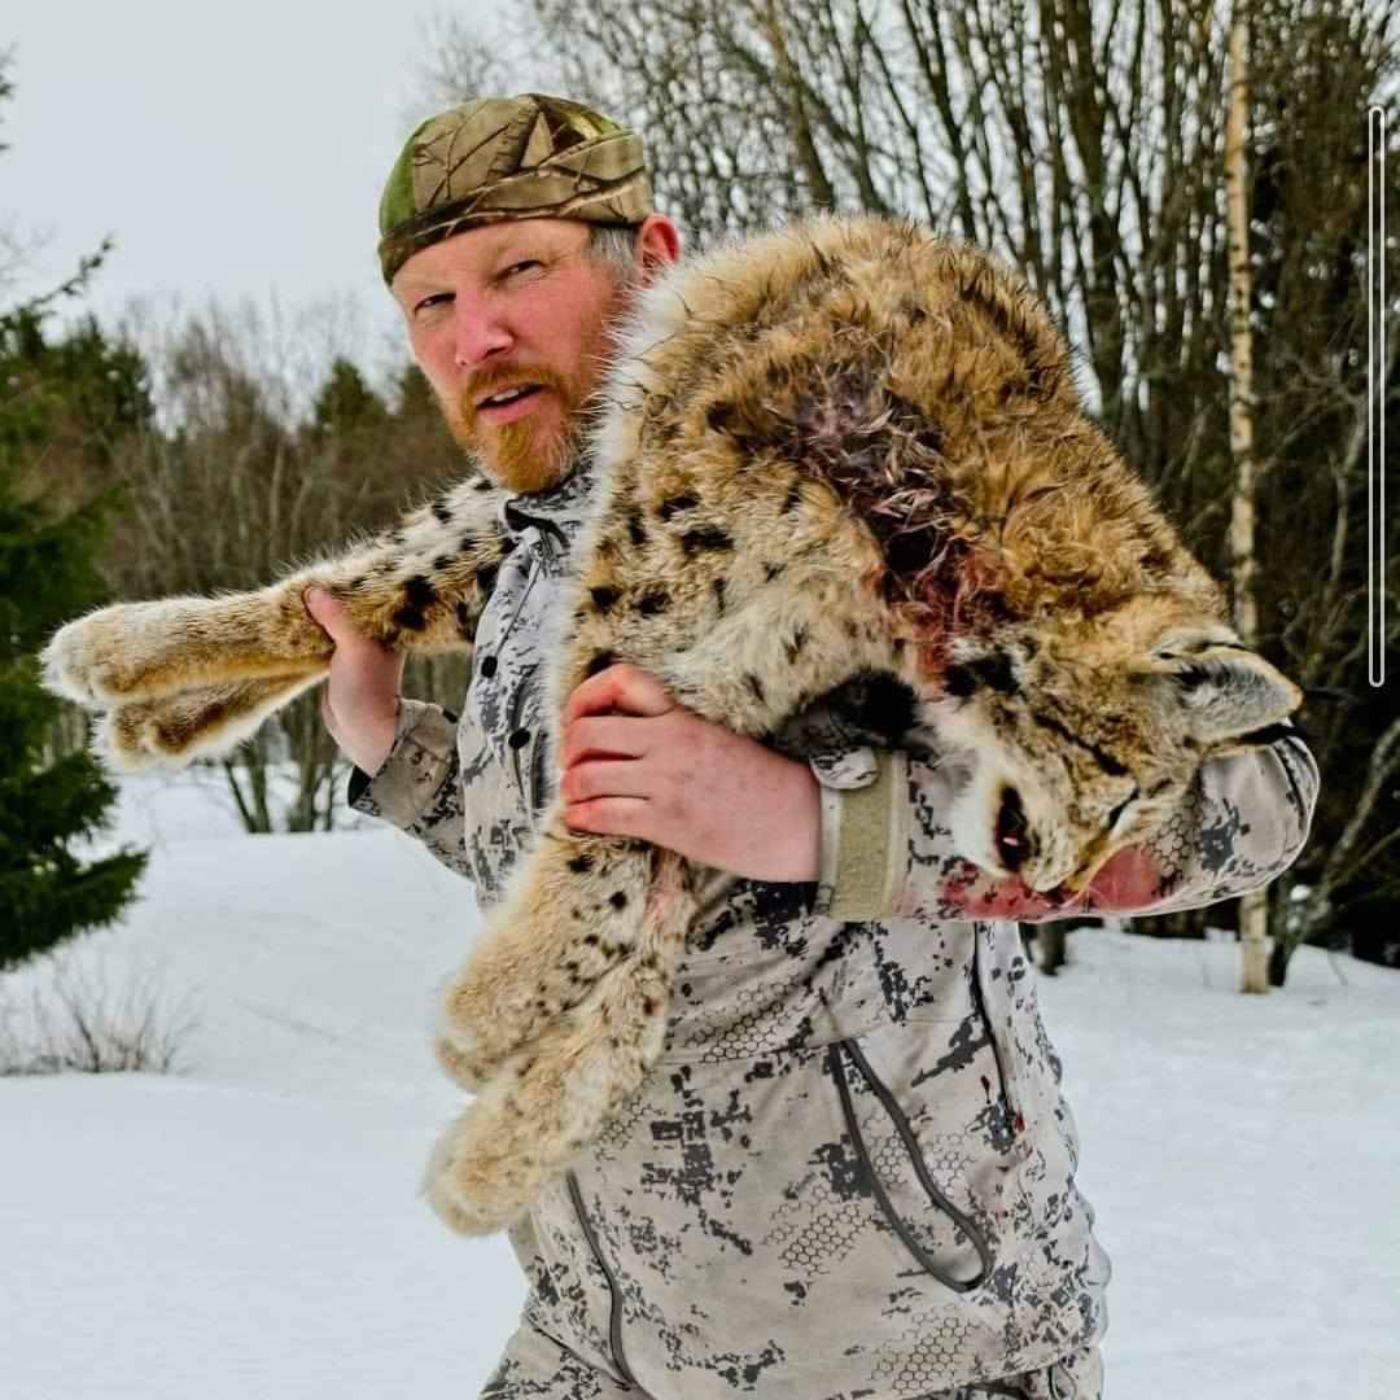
[{"left": 305, "top": 588, "right": 403, "bottom": 774}]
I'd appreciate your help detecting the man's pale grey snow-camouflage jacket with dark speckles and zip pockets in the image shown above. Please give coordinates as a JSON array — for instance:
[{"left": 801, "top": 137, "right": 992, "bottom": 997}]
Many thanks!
[{"left": 351, "top": 473, "right": 1317, "bottom": 1400}]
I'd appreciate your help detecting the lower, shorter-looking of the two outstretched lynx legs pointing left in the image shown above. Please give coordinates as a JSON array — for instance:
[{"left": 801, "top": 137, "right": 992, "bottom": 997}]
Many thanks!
[{"left": 94, "top": 671, "right": 323, "bottom": 773}]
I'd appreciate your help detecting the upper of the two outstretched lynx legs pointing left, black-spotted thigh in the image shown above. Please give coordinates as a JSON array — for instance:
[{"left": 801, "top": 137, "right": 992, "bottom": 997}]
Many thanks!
[{"left": 43, "top": 473, "right": 507, "bottom": 708}]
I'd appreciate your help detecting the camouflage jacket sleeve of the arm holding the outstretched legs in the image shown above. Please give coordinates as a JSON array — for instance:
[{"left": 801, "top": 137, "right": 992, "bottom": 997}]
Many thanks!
[{"left": 346, "top": 700, "right": 473, "bottom": 876}]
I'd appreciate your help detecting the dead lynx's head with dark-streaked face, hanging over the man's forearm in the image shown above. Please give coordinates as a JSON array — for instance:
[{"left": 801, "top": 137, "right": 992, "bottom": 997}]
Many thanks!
[{"left": 930, "top": 599, "right": 1301, "bottom": 893}]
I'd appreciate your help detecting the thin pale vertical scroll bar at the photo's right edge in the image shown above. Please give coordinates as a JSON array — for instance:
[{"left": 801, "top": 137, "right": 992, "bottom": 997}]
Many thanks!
[{"left": 1366, "top": 105, "right": 1386, "bottom": 686}]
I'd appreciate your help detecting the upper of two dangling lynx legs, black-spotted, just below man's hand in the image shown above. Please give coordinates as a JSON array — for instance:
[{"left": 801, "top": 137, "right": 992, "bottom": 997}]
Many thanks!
[{"left": 438, "top": 823, "right": 652, "bottom": 1089}]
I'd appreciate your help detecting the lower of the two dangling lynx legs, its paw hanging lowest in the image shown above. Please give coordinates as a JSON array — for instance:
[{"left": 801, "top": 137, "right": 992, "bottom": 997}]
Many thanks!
[{"left": 424, "top": 929, "right": 671, "bottom": 1235}]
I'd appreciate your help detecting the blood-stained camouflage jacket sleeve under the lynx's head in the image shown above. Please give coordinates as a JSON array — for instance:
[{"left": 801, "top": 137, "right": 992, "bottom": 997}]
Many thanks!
[{"left": 812, "top": 731, "right": 1317, "bottom": 923}]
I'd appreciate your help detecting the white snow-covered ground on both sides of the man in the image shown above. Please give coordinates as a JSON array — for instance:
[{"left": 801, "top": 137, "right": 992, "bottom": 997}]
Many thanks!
[{"left": 0, "top": 778, "right": 1400, "bottom": 1400}]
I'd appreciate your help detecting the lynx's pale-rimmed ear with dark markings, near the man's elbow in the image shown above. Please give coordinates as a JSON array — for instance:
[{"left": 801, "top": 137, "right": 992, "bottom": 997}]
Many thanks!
[{"left": 1156, "top": 643, "right": 1303, "bottom": 745}]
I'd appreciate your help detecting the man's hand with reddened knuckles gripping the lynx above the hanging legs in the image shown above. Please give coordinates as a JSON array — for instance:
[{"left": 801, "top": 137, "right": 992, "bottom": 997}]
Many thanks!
[{"left": 560, "top": 665, "right": 820, "bottom": 881}]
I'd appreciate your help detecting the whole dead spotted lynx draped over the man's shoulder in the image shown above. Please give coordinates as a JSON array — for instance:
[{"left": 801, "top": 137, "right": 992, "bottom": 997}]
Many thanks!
[{"left": 46, "top": 212, "right": 1298, "bottom": 1232}]
